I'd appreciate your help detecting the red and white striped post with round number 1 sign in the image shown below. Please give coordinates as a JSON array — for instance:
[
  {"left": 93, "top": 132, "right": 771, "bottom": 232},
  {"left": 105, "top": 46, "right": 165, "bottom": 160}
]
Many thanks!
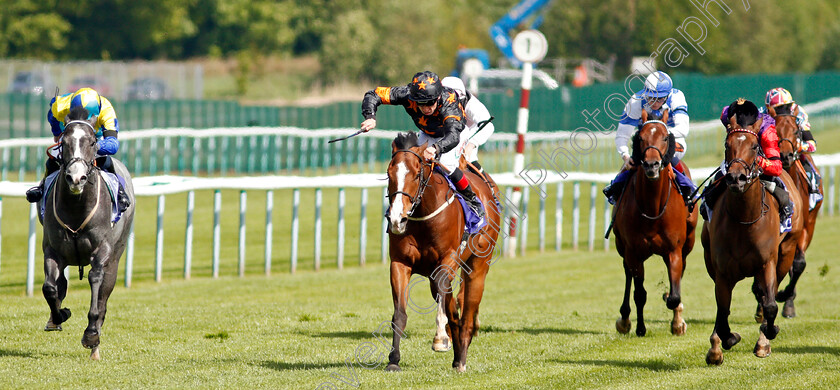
[{"left": 508, "top": 30, "right": 548, "bottom": 257}]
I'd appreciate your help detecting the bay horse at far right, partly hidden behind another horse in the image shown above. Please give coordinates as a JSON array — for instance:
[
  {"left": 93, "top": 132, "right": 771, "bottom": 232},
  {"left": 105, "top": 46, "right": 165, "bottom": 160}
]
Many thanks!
[{"left": 768, "top": 104, "right": 823, "bottom": 318}]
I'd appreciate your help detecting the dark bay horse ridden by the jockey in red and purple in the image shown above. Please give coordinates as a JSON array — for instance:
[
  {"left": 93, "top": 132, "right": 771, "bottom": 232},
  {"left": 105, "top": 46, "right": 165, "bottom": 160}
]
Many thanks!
[{"left": 701, "top": 107, "right": 807, "bottom": 365}]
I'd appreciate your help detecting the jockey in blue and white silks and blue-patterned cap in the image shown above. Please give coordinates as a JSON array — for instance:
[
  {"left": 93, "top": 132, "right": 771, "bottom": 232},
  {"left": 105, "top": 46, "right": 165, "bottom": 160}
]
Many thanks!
[{"left": 604, "top": 71, "right": 696, "bottom": 204}]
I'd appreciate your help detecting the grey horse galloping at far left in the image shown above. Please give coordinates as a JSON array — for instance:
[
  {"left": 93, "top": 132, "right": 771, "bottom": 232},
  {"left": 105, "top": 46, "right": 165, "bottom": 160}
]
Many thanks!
[{"left": 42, "top": 107, "right": 135, "bottom": 360}]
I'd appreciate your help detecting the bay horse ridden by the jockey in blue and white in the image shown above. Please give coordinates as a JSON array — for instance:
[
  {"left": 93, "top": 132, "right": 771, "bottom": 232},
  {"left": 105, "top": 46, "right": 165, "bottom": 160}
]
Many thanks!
[{"left": 613, "top": 111, "right": 697, "bottom": 336}]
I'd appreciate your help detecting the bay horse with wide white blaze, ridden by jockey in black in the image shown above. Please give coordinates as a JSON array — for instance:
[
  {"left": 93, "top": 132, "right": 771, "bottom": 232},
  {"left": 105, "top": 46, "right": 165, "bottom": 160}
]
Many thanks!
[{"left": 386, "top": 132, "right": 500, "bottom": 372}]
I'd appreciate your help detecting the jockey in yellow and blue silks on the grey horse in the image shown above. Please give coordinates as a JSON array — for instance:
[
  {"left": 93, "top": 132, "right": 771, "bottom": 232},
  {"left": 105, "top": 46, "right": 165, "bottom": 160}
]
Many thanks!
[{"left": 26, "top": 88, "right": 130, "bottom": 211}]
